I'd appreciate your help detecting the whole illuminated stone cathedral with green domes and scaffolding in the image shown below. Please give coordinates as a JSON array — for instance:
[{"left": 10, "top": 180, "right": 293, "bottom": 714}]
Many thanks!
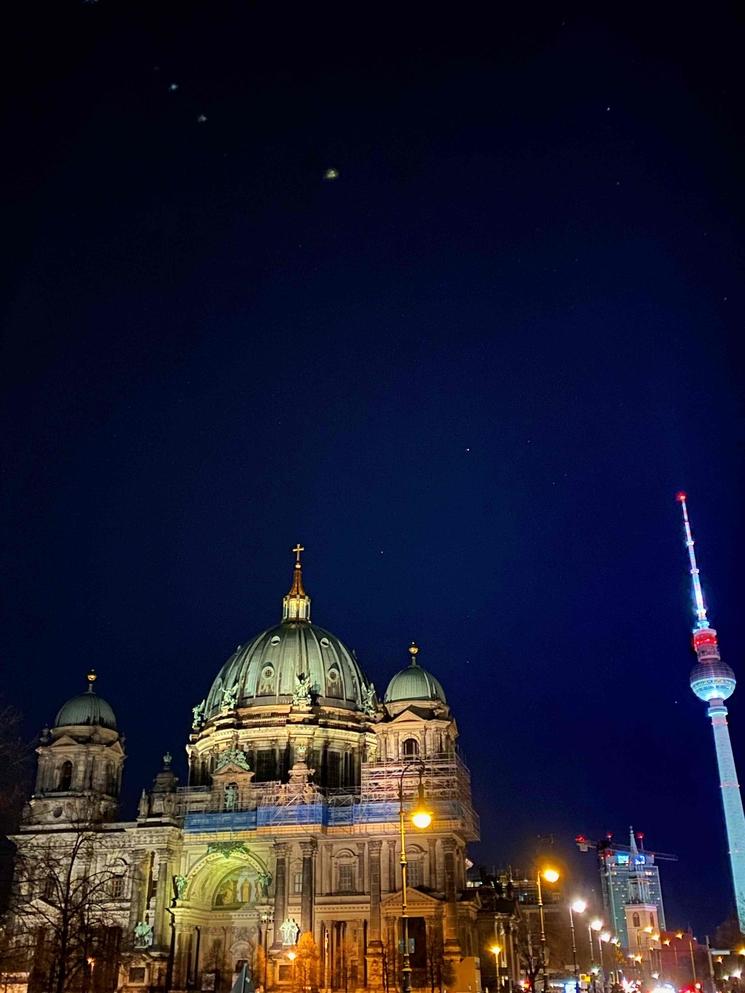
[{"left": 14, "top": 546, "right": 479, "bottom": 993}]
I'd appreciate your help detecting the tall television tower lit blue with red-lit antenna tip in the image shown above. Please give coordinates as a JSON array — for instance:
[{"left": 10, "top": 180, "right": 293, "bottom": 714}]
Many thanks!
[{"left": 676, "top": 493, "right": 745, "bottom": 932}]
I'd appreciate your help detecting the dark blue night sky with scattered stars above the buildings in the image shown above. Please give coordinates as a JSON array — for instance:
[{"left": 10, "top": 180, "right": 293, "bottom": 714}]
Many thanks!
[{"left": 0, "top": 0, "right": 745, "bottom": 935}]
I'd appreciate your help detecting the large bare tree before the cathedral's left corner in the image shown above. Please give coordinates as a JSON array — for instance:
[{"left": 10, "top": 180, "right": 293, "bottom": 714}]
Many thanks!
[{"left": 9, "top": 804, "right": 128, "bottom": 993}]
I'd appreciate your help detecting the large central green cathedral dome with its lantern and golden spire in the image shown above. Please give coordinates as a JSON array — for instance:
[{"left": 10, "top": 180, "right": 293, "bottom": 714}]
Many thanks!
[{"left": 203, "top": 553, "right": 374, "bottom": 720}]
